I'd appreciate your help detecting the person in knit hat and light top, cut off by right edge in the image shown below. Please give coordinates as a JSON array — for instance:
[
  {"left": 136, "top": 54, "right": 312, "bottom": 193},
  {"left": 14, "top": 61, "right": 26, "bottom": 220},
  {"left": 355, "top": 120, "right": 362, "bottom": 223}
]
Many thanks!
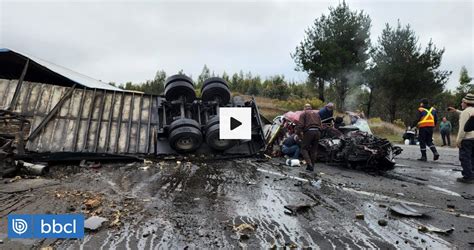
[{"left": 449, "top": 94, "right": 474, "bottom": 184}]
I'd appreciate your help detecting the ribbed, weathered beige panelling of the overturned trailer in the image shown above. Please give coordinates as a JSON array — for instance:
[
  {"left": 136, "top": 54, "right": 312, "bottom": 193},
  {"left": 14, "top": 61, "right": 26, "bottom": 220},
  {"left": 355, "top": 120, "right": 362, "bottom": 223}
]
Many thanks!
[{"left": 0, "top": 79, "right": 160, "bottom": 154}]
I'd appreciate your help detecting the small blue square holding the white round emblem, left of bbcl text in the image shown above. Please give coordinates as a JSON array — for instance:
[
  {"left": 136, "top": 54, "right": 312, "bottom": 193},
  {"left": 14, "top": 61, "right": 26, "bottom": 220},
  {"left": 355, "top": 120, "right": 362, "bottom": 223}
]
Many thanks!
[{"left": 8, "top": 214, "right": 33, "bottom": 239}]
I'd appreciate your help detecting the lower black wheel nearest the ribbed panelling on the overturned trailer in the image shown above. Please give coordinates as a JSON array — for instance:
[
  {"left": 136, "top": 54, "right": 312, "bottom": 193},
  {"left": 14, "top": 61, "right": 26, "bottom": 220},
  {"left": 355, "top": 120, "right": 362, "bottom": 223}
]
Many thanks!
[{"left": 168, "top": 126, "right": 202, "bottom": 153}]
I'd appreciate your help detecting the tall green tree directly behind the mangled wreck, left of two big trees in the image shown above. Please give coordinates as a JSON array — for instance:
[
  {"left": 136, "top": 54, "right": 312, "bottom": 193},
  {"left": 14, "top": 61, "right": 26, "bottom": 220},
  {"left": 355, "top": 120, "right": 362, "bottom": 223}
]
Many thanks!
[{"left": 292, "top": 2, "right": 371, "bottom": 109}]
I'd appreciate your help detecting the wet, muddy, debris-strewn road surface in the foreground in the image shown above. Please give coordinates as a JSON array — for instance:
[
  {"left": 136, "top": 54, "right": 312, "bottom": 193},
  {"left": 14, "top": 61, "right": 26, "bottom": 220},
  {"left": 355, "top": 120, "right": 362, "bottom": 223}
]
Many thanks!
[{"left": 0, "top": 147, "right": 474, "bottom": 249}]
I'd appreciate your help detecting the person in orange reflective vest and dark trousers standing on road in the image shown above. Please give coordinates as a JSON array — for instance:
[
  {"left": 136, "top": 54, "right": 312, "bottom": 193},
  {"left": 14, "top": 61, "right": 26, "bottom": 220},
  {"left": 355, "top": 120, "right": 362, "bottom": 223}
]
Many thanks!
[{"left": 414, "top": 98, "right": 439, "bottom": 161}]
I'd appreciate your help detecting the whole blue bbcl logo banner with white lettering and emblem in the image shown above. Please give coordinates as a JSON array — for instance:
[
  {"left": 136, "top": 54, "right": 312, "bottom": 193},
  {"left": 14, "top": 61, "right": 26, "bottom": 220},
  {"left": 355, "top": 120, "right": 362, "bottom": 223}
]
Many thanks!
[{"left": 8, "top": 214, "right": 84, "bottom": 239}]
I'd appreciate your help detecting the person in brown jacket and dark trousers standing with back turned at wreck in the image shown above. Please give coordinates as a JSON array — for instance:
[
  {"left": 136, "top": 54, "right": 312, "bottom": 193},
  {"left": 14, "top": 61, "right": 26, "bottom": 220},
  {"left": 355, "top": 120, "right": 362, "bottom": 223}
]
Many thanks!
[{"left": 298, "top": 103, "right": 321, "bottom": 172}]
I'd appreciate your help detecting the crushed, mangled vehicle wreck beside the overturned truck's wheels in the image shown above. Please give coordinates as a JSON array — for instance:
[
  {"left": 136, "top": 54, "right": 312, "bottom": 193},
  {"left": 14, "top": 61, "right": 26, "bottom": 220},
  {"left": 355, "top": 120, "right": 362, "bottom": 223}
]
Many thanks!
[{"left": 265, "top": 110, "right": 402, "bottom": 170}]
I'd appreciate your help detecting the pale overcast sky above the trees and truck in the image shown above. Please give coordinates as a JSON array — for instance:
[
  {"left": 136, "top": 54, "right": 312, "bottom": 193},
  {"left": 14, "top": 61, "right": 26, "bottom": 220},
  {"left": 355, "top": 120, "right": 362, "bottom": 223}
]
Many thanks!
[{"left": 0, "top": 0, "right": 474, "bottom": 89}]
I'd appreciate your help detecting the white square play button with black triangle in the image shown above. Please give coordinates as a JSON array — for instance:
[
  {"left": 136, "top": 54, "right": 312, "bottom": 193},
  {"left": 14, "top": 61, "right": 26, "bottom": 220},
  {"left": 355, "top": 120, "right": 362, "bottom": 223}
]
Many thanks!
[{"left": 219, "top": 107, "right": 252, "bottom": 140}]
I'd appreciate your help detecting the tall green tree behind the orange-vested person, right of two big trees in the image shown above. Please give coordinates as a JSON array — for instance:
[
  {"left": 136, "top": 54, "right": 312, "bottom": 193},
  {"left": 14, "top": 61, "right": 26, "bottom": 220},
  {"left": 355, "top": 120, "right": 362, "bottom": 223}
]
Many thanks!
[{"left": 371, "top": 22, "right": 451, "bottom": 123}]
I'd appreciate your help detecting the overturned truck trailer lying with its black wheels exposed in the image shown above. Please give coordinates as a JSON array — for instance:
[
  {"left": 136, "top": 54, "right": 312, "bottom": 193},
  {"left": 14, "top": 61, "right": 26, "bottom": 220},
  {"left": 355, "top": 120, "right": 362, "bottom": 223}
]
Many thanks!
[{"left": 0, "top": 49, "right": 265, "bottom": 161}]
